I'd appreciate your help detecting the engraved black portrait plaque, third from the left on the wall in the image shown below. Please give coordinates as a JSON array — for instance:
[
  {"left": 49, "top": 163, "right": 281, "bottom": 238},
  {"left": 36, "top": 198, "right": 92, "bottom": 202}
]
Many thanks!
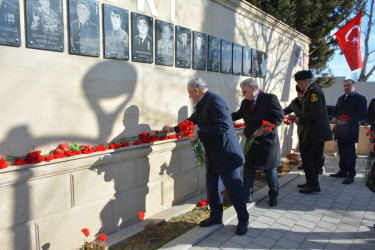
[{"left": 69, "top": 0, "right": 100, "bottom": 56}]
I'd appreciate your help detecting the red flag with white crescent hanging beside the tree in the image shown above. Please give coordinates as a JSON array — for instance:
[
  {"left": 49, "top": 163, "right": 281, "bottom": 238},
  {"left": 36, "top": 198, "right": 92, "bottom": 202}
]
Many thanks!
[{"left": 335, "top": 12, "right": 363, "bottom": 71}]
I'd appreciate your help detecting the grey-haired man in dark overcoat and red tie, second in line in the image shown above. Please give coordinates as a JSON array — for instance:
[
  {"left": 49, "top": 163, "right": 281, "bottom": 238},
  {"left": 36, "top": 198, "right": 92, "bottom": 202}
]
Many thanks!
[{"left": 232, "top": 78, "right": 284, "bottom": 207}]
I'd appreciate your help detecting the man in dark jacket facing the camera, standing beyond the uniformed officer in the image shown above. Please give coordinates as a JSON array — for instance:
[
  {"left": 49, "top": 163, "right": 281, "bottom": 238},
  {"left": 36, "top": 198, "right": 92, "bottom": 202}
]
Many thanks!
[{"left": 330, "top": 79, "right": 367, "bottom": 184}]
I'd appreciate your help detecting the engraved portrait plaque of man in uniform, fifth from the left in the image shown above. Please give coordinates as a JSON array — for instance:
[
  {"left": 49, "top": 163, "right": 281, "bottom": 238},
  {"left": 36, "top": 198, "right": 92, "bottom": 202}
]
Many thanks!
[{"left": 132, "top": 12, "right": 154, "bottom": 63}]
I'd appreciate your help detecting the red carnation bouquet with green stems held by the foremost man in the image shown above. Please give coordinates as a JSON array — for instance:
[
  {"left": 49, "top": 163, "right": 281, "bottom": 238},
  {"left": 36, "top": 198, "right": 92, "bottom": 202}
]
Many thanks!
[{"left": 178, "top": 120, "right": 206, "bottom": 168}]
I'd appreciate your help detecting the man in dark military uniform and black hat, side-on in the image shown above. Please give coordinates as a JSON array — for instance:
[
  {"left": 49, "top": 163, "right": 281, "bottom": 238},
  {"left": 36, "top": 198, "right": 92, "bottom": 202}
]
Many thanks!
[{"left": 294, "top": 70, "right": 332, "bottom": 194}]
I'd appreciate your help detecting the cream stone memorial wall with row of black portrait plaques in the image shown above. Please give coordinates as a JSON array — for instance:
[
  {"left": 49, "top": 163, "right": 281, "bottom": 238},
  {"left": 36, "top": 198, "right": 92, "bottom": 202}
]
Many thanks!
[{"left": 0, "top": 0, "right": 310, "bottom": 249}]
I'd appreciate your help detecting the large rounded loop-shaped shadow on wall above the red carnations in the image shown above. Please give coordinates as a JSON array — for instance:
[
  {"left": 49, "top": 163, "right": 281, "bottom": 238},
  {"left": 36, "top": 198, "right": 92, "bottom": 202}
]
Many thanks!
[{"left": 0, "top": 60, "right": 137, "bottom": 155}]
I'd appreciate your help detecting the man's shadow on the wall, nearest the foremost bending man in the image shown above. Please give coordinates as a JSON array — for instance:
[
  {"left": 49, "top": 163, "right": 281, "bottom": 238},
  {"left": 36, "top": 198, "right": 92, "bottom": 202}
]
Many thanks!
[{"left": 90, "top": 105, "right": 151, "bottom": 234}]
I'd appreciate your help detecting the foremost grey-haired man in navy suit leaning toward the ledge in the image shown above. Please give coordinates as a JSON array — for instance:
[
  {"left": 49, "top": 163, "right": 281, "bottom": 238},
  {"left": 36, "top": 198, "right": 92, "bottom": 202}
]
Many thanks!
[{"left": 164, "top": 78, "right": 249, "bottom": 235}]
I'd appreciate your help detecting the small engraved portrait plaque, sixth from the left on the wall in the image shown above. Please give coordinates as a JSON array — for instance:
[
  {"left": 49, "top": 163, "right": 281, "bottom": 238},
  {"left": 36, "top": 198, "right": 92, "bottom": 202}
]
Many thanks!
[{"left": 155, "top": 20, "right": 174, "bottom": 66}]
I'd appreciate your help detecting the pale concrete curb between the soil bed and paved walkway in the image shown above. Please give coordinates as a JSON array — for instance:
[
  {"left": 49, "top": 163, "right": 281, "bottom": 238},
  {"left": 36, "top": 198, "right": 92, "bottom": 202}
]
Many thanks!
[{"left": 160, "top": 172, "right": 301, "bottom": 250}]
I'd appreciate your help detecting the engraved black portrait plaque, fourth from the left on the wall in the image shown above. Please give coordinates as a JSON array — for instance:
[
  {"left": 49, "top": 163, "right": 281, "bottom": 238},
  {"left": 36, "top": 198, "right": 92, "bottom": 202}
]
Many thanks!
[{"left": 103, "top": 4, "right": 129, "bottom": 60}]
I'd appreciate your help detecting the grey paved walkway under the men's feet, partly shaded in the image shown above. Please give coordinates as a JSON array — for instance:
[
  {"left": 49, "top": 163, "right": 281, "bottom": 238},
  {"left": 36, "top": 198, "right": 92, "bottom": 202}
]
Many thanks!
[{"left": 162, "top": 156, "right": 375, "bottom": 250}]
